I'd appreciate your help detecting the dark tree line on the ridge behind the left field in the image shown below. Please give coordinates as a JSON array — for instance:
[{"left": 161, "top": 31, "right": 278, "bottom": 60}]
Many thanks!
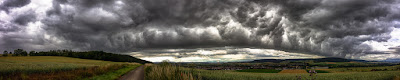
[{"left": 2, "top": 49, "right": 151, "bottom": 64}]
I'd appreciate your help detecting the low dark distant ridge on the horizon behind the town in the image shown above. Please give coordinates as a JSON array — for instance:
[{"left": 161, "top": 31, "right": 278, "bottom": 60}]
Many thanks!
[{"left": 250, "top": 57, "right": 369, "bottom": 63}]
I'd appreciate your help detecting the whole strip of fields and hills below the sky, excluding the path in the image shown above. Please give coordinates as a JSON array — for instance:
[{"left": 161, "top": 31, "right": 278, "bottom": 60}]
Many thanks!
[{"left": 0, "top": 49, "right": 400, "bottom": 80}]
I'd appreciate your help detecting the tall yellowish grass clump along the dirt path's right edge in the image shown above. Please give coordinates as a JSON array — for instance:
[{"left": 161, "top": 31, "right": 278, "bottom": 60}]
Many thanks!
[{"left": 145, "top": 62, "right": 202, "bottom": 80}]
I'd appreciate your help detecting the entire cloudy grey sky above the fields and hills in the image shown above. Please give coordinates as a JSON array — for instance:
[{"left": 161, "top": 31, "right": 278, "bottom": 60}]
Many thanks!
[{"left": 0, "top": 0, "right": 400, "bottom": 62}]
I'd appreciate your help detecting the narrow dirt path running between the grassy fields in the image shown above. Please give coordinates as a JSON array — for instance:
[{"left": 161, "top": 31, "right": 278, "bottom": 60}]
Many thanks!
[{"left": 119, "top": 65, "right": 144, "bottom": 80}]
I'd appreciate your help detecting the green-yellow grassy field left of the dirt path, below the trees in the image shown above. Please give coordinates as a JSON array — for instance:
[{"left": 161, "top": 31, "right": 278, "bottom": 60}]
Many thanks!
[{"left": 0, "top": 56, "right": 140, "bottom": 80}]
